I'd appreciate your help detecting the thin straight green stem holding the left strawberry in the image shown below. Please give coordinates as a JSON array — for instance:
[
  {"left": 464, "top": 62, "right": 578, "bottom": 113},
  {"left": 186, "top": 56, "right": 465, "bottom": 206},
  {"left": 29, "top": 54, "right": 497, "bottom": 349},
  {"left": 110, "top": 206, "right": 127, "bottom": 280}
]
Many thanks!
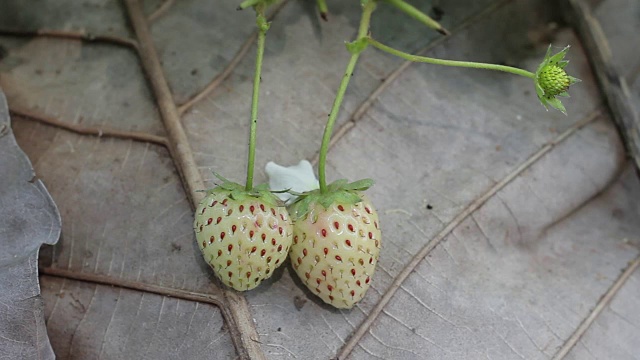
[{"left": 245, "top": 4, "right": 269, "bottom": 191}]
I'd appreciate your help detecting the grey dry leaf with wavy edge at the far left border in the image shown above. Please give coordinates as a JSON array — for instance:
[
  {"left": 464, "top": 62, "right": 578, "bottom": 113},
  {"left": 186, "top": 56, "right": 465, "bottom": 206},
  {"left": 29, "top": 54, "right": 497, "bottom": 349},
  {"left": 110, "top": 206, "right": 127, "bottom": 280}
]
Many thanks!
[{"left": 0, "top": 91, "right": 60, "bottom": 359}]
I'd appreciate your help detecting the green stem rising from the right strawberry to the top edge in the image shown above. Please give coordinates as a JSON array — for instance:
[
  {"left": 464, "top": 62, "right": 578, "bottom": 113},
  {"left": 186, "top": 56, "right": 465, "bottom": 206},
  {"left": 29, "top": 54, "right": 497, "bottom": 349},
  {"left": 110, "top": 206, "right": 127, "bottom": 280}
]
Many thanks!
[{"left": 318, "top": 0, "right": 376, "bottom": 194}]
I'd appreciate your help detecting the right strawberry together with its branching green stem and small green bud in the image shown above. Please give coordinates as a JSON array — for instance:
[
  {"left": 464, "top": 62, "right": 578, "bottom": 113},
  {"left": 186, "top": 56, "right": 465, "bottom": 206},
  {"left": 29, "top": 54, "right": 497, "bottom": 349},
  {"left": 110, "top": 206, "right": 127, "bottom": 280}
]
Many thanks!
[{"left": 280, "top": 0, "right": 579, "bottom": 308}]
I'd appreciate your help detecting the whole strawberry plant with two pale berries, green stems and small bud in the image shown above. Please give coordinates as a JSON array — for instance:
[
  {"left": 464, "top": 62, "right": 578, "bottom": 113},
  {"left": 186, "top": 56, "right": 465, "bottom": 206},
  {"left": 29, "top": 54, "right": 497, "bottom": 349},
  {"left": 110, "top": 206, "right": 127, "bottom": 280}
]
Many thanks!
[{"left": 194, "top": 0, "right": 579, "bottom": 308}]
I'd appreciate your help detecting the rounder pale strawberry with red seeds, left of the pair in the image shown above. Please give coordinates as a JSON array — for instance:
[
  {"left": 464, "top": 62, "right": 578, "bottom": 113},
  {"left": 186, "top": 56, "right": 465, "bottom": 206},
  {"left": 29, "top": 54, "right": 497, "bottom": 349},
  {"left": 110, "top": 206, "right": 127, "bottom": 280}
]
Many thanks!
[{"left": 194, "top": 176, "right": 293, "bottom": 291}]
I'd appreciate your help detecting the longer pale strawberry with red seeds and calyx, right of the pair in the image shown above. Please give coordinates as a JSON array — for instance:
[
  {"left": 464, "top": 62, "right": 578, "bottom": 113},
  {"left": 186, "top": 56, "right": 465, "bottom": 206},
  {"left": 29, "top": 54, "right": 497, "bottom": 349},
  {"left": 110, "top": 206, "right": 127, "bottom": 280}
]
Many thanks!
[{"left": 289, "top": 180, "right": 381, "bottom": 308}]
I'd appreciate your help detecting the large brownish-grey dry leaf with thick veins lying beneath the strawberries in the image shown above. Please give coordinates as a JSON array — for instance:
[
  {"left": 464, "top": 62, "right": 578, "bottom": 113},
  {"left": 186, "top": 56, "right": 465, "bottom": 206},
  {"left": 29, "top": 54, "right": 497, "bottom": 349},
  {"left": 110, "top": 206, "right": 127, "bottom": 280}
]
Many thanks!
[{"left": 0, "top": 0, "right": 640, "bottom": 359}]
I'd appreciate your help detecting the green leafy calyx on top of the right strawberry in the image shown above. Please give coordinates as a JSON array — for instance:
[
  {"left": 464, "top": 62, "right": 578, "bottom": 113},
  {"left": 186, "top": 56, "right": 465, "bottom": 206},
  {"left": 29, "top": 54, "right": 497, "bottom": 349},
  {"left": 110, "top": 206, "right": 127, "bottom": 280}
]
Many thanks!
[{"left": 289, "top": 179, "right": 373, "bottom": 220}]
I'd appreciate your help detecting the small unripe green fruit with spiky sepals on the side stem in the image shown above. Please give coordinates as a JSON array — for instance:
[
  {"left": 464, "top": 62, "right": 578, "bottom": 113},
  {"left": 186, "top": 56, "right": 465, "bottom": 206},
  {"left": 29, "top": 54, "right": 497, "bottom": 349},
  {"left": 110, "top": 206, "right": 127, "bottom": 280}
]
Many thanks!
[{"left": 535, "top": 45, "right": 580, "bottom": 115}]
